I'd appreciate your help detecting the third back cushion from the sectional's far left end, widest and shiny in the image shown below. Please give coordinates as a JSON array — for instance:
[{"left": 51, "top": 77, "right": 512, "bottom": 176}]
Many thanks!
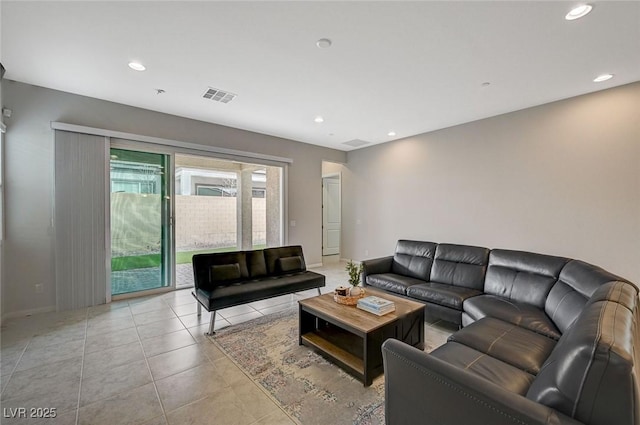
[{"left": 484, "top": 249, "right": 569, "bottom": 309}]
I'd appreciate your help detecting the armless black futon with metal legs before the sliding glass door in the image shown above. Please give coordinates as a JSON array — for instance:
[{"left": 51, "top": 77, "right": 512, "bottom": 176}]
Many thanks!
[{"left": 192, "top": 245, "right": 325, "bottom": 335}]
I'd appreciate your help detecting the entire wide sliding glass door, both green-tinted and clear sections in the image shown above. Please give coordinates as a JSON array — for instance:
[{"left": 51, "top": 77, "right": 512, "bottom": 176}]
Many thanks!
[{"left": 110, "top": 146, "right": 284, "bottom": 296}]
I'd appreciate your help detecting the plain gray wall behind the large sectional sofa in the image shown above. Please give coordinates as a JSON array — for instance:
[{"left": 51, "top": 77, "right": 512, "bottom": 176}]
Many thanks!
[{"left": 343, "top": 83, "right": 640, "bottom": 284}]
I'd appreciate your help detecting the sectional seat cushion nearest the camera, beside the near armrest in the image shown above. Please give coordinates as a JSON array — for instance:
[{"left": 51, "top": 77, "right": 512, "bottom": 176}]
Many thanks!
[{"left": 430, "top": 342, "right": 534, "bottom": 395}]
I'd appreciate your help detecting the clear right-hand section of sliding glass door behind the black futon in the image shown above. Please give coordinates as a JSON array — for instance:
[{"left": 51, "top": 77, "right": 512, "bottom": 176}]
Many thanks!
[{"left": 175, "top": 154, "right": 283, "bottom": 288}]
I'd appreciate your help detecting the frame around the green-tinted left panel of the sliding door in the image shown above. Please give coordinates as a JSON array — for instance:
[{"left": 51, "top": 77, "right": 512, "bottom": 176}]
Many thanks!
[{"left": 107, "top": 138, "right": 176, "bottom": 302}]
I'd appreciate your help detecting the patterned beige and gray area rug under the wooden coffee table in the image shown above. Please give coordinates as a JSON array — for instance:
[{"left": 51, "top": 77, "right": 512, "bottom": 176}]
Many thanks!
[{"left": 210, "top": 309, "right": 448, "bottom": 425}]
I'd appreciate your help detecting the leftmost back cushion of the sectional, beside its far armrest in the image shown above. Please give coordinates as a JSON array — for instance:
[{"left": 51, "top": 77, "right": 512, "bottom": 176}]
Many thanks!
[{"left": 391, "top": 240, "right": 437, "bottom": 281}]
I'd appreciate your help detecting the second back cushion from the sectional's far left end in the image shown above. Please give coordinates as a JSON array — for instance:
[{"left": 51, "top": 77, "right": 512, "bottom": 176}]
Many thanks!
[{"left": 430, "top": 243, "right": 489, "bottom": 290}]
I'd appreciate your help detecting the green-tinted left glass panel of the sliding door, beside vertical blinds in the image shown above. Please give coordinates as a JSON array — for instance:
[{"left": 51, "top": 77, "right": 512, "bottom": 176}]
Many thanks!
[{"left": 110, "top": 148, "right": 172, "bottom": 295}]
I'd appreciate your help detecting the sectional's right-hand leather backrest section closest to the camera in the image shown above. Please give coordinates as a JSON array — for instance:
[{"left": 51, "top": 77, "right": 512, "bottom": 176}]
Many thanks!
[{"left": 527, "top": 282, "right": 640, "bottom": 425}]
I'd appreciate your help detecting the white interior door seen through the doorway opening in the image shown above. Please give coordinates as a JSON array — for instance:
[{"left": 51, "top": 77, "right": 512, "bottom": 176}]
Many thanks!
[{"left": 322, "top": 175, "right": 342, "bottom": 255}]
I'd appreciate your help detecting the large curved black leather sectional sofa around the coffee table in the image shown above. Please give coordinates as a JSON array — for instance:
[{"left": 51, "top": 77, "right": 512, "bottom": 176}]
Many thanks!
[{"left": 363, "top": 240, "right": 640, "bottom": 425}]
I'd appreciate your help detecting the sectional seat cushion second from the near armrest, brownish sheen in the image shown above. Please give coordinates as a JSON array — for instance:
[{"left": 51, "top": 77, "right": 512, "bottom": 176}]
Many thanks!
[{"left": 449, "top": 317, "right": 556, "bottom": 375}]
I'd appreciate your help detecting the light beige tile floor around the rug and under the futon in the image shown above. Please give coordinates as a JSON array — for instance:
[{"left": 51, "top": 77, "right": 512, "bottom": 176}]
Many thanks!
[{"left": 0, "top": 263, "right": 452, "bottom": 425}]
